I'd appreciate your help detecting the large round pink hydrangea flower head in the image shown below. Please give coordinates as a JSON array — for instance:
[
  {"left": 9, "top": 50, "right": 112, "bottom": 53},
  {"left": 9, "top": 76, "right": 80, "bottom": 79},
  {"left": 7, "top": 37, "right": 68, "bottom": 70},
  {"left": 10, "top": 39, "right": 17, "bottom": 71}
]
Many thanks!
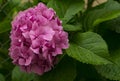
[{"left": 9, "top": 3, "right": 69, "bottom": 75}]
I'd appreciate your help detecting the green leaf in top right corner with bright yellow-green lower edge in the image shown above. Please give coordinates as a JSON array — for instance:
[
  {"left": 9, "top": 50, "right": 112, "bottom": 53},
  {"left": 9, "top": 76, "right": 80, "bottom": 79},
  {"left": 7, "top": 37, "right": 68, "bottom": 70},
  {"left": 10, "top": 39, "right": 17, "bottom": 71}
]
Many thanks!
[{"left": 84, "top": 0, "right": 120, "bottom": 29}]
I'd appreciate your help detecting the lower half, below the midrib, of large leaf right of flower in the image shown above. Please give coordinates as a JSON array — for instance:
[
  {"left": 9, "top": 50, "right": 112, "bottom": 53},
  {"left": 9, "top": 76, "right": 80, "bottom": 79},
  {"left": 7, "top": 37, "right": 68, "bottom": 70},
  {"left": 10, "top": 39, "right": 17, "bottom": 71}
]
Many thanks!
[{"left": 67, "top": 44, "right": 110, "bottom": 65}]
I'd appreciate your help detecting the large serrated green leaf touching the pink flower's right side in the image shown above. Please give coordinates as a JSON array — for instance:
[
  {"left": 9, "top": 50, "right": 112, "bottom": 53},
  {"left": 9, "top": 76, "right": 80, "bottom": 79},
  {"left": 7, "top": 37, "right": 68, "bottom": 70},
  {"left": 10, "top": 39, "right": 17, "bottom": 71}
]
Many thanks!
[{"left": 67, "top": 32, "right": 111, "bottom": 65}]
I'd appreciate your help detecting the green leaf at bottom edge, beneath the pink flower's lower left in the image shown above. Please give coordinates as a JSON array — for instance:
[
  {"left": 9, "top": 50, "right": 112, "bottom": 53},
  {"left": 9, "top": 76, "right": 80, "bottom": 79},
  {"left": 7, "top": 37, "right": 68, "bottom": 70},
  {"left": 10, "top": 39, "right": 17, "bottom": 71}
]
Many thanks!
[{"left": 12, "top": 66, "right": 34, "bottom": 81}]
